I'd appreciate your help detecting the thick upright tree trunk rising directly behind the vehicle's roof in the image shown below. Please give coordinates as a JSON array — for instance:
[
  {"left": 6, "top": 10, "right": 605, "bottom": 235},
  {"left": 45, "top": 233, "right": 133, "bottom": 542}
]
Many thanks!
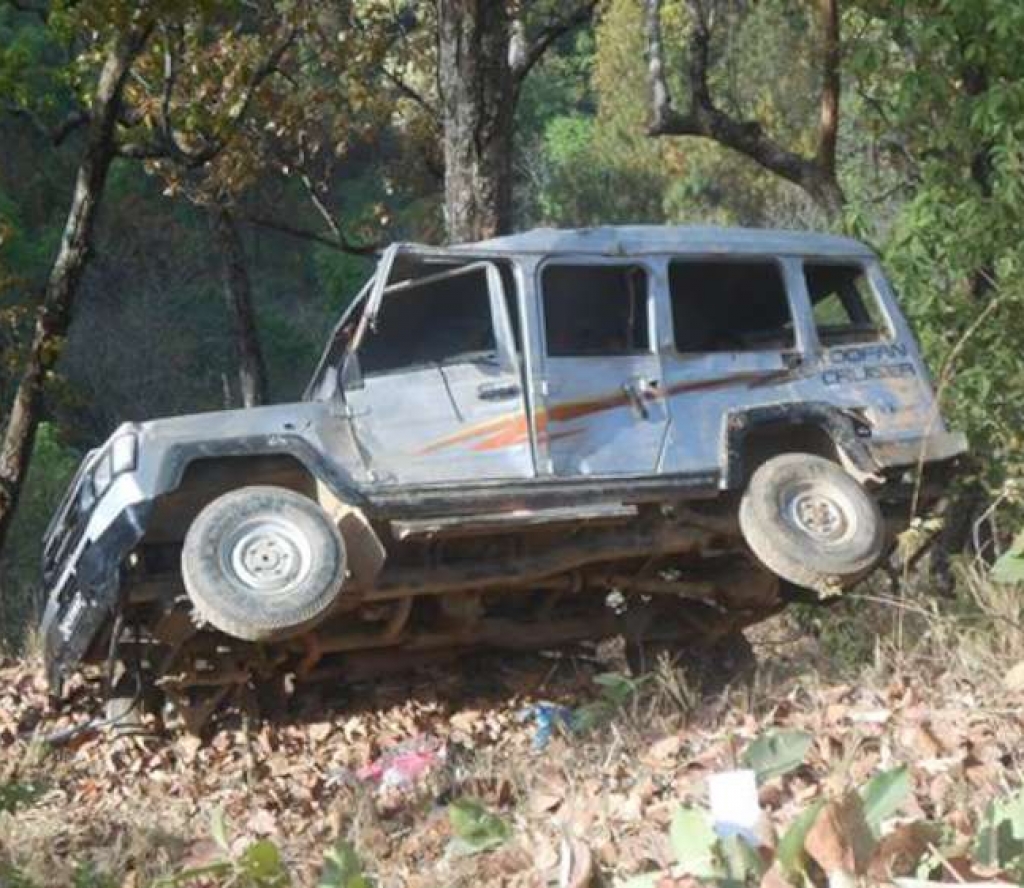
[{"left": 437, "top": 0, "right": 515, "bottom": 243}]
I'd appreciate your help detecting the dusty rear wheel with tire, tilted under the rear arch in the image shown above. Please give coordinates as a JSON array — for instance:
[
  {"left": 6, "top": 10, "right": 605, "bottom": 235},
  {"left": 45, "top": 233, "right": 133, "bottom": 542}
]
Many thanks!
[{"left": 739, "top": 454, "right": 885, "bottom": 595}]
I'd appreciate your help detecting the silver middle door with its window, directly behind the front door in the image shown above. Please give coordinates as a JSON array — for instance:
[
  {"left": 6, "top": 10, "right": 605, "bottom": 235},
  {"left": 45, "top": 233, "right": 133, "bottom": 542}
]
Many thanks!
[{"left": 538, "top": 259, "right": 669, "bottom": 475}]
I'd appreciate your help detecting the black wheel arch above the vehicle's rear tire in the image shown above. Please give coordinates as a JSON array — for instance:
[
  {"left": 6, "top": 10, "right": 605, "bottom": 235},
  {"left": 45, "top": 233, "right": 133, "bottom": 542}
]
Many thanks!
[{"left": 722, "top": 403, "right": 878, "bottom": 490}]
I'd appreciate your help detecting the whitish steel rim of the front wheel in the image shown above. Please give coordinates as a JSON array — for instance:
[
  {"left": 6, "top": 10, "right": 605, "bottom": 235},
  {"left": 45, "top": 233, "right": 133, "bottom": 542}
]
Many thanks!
[{"left": 219, "top": 516, "right": 312, "bottom": 595}]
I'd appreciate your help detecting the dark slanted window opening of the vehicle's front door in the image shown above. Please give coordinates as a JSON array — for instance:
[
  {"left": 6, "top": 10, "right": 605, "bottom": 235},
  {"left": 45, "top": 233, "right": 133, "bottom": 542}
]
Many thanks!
[{"left": 359, "top": 267, "right": 497, "bottom": 377}]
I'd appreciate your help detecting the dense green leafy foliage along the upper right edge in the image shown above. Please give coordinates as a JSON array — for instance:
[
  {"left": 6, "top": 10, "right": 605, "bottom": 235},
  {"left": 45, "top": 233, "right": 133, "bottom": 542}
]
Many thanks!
[{"left": 848, "top": 0, "right": 1024, "bottom": 487}]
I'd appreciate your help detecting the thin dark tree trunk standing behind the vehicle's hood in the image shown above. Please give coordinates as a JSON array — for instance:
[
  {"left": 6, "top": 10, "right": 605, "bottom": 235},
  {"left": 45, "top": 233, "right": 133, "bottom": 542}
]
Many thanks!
[{"left": 210, "top": 206, "right": 266, "bottom": 407}]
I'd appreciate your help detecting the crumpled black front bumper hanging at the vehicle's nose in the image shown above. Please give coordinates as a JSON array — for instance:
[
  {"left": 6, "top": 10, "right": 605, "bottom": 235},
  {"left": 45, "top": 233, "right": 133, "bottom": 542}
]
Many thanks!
[{"left": 40, "top": 503, "right": 150, "bottom": 695}]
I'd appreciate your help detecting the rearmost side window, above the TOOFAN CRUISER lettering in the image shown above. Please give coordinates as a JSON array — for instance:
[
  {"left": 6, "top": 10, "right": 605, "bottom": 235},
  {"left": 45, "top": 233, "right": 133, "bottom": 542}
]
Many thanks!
[{"left": 804, "top": 262, "right": 889, "bottom": 345}]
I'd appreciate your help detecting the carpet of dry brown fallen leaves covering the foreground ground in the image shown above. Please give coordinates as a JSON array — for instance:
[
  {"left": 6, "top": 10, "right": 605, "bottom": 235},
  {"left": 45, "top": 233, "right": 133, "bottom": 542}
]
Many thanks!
[{"left": 0, "top": 657, "right": 1024, "bottom": 888}]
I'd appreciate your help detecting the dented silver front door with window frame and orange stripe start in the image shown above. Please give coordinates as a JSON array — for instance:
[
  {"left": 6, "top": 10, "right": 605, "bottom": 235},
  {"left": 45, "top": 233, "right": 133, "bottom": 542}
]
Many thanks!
[{"left": 343, "top": 256, "right": 534, "bottom": 485}]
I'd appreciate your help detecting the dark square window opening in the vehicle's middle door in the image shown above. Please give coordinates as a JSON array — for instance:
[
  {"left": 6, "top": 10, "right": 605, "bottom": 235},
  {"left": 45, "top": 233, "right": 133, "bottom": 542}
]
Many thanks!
[{"left": 541, "top": 265, "right": 650, "bottom": 357}]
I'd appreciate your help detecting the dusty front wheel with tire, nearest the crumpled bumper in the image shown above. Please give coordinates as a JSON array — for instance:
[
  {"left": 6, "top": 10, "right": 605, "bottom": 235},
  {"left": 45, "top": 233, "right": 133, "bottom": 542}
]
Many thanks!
[{"left": 181, "top": 487, "right": 346, "bottom": 641}]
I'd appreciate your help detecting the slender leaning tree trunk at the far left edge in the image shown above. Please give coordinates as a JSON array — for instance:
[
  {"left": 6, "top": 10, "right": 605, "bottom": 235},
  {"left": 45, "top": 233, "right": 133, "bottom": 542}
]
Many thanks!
[{"left": 0, "top": 27, "right": 150, "bottom": 550}]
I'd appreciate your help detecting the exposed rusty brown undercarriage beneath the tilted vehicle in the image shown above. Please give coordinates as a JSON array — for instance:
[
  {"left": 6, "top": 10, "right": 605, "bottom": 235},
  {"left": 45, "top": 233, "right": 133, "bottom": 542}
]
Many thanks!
[{"left": 94, "top": 507, "right": 783, "bottom": 730}]
